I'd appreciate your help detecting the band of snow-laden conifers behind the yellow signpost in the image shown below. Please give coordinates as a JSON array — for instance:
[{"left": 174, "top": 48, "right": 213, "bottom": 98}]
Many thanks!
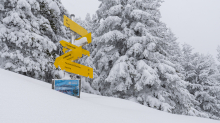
[{"left": 0, "top": 0, "right": 220, "bottom": 120}]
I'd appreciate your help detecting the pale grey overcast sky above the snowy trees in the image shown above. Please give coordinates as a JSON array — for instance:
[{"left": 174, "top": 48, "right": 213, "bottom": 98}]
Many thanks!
[{"left": 61, "top": 0, "right": 220, "bottom": 61}]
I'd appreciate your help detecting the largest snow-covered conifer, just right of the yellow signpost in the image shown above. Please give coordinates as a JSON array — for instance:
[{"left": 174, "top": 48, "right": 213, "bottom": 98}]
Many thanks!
[{"left": 92, "top": 0, "right": 196, "bottom": 115}]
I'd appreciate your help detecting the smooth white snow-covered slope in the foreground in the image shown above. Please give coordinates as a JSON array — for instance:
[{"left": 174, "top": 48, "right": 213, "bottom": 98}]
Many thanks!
[{"left": 0, "top": 69, "right": 219, "bottom": 123}]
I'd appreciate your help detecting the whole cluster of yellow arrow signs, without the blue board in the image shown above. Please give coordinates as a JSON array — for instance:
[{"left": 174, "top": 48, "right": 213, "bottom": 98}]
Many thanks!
[{"left": 54, "top": 15, "right": 93, "bottom": 78}]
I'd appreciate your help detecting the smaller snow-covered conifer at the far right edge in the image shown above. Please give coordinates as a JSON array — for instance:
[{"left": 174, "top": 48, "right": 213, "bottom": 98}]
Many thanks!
[{"left": 182, "top": 44, "right": 220, "bottom": 119}]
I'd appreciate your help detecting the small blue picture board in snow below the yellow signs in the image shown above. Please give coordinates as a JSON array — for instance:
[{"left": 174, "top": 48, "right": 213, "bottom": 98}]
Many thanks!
[{"left": 54, "top": 80, "right": 79, "bottom": 96}]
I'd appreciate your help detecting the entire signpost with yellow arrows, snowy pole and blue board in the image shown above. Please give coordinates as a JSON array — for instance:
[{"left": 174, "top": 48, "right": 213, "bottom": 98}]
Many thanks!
[{"left": 52, "top": 15, "right": 93, "bottom": 97}]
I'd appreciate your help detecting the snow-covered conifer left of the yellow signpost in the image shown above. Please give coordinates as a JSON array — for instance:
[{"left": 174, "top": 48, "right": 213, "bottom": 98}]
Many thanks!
[{"left": 0, "top": 0, "right": 69, "bottom": 81}]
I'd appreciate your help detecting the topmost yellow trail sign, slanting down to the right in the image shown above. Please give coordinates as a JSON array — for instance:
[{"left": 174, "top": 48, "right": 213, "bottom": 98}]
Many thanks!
[{"left": 63, "top": 15, "right": 88, "bottom": 36}]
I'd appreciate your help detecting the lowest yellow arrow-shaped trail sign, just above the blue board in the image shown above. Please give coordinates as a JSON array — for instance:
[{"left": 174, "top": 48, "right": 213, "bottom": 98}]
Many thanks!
[{"left": 59, "top": 59, "right": 93, "bottom": 78}]
